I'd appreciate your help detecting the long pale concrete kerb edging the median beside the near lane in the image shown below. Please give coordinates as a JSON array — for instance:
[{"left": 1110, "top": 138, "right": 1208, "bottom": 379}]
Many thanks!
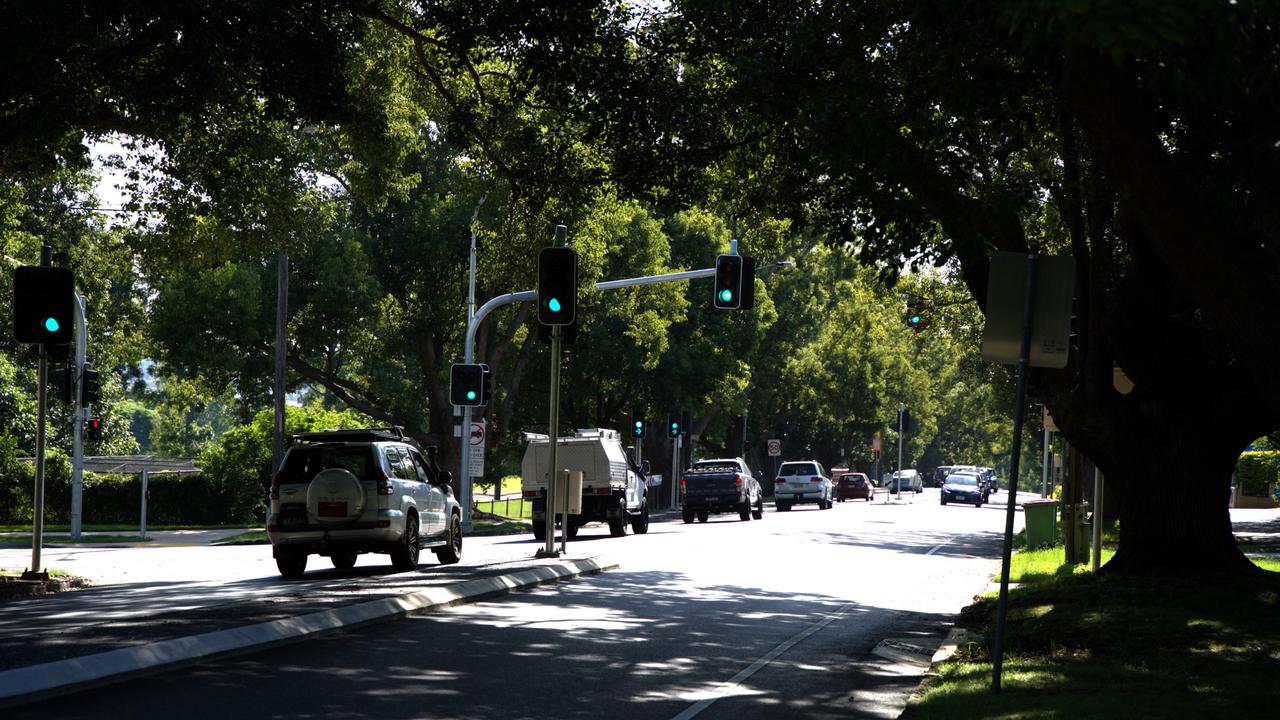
[{"left": 0, "top": 550, "right": 617, "bottom": 707}]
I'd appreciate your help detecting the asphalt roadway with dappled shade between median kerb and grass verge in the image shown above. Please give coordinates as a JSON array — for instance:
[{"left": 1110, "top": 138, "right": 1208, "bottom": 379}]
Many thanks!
[{"left": 7, "top": 489, "right": 1020, "bottom": 719}]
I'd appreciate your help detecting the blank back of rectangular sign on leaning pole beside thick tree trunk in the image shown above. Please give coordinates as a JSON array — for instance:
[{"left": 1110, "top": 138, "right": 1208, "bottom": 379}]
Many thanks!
[{"left": 982, "top": 252, "right": 1075, "bottom": 368}]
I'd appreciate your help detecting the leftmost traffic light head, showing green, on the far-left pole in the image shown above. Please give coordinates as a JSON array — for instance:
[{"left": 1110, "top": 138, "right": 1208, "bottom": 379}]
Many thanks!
[{"left": 13, "top": 265, "right": 76, "bottom": 345}]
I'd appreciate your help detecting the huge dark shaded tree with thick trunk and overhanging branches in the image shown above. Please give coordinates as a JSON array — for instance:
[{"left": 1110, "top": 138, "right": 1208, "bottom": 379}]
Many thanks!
[{"left": 471, "top": 0, "right": 1280, "bottom": 573}]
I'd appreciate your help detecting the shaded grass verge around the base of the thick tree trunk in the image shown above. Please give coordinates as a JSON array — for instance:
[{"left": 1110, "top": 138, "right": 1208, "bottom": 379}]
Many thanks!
[{"left": 902, "top": 556, "right": 1280, "bottom": 720}]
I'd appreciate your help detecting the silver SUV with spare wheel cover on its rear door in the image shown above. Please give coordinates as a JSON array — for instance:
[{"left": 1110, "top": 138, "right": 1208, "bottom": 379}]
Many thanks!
[{"left": 266, "top": 428, "right": 462, "bottom": 578}]
